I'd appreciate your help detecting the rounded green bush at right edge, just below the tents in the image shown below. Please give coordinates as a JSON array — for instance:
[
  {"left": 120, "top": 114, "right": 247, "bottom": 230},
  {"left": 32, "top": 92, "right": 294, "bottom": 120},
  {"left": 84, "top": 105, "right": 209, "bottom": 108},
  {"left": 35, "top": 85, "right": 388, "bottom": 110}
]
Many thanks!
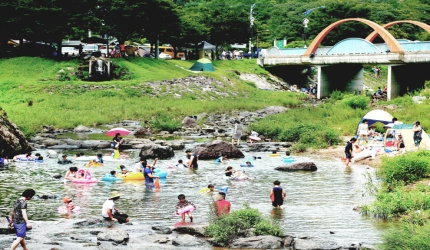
[{"left": 378, "top": 151, "right": 430, "bottom": 185}]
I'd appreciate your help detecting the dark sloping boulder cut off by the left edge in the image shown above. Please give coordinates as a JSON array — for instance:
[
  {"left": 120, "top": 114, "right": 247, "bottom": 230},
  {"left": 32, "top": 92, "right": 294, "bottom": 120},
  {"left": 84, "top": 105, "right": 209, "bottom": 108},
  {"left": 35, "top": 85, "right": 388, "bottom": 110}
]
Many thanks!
[{"left": 0, "top": 108, "right": 33, "bottom": 158}]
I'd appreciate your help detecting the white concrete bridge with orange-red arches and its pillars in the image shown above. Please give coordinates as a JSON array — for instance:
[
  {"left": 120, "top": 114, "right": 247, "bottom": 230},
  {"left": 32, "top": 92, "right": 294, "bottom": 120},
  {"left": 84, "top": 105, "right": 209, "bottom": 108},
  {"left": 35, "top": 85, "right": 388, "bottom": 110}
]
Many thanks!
[{"left": 257, "top": 18, "right": 430, "bottom": 99}]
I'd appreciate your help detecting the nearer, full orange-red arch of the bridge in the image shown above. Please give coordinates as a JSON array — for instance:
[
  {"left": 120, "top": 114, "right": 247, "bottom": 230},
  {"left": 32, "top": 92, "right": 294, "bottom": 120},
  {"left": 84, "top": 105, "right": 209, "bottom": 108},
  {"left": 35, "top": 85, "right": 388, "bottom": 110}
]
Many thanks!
[{"left": 303, "top": 18, "right": 405, "bottom": 56}]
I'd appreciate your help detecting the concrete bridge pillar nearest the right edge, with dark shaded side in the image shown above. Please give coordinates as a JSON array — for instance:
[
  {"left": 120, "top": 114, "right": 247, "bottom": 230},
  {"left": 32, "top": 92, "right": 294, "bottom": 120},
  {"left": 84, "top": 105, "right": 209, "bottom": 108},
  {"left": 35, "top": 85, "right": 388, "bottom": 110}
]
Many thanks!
[{"left": 387, "top": 64, "right": 430, "bottom": 100}]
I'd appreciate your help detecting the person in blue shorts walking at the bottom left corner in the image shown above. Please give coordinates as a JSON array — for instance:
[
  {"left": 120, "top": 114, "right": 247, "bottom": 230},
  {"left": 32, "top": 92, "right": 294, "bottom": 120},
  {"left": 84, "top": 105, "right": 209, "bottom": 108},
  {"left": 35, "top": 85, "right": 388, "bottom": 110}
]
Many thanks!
[{"left": 10, "top": 189, "right": 36, "bottom": 250}]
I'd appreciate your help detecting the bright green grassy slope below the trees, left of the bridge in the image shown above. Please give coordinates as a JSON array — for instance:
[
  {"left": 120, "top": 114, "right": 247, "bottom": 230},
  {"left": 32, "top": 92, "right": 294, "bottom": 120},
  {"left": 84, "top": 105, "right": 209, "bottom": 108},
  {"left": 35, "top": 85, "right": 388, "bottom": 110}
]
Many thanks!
[{"left": 0, "top": 57, "right": 301, "bottom": 135}]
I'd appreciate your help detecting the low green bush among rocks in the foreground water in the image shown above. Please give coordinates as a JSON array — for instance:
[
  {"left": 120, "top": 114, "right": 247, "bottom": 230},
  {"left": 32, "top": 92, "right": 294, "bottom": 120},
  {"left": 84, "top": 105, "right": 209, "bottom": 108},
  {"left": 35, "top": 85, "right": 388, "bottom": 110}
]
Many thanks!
[{"left": 206, "top": 204, "right": 282, "bottom": 245}]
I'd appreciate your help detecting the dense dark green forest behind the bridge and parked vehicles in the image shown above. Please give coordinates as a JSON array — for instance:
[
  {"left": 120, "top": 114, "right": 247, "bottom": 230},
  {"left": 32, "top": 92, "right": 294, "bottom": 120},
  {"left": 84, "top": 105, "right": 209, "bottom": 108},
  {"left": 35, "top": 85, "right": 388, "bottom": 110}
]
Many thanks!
[{"left": 0, "top": 0, "right": 430, "bottom": 54}]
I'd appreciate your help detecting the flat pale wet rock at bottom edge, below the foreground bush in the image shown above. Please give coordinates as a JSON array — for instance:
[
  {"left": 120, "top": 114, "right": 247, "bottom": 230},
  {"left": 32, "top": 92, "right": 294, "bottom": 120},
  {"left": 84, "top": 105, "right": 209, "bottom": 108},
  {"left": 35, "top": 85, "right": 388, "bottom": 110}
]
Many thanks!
[{"left": 231, "top": 235, "right": 282, "bottom": 249}]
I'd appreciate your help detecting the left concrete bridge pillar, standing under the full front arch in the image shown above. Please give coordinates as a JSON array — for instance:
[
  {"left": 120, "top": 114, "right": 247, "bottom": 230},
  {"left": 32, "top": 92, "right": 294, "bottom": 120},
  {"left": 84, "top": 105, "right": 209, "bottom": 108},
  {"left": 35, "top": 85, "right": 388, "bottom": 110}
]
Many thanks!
[{"left": 317, "top": 64, "right": 364, "bottom": 99}]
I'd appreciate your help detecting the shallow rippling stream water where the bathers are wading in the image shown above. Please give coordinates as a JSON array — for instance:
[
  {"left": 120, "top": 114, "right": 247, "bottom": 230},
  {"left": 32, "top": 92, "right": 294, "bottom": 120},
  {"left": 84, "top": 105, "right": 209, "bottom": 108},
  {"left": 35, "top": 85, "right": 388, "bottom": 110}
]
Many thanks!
[{"left": 0, "top": 150, "right": 384, "bottom": 243}]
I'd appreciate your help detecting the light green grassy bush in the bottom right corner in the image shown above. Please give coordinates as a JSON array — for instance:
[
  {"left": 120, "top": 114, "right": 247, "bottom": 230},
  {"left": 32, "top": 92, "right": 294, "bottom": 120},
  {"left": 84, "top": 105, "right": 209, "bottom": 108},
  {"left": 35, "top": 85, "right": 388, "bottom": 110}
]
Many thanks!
[{"left": 380, "top": 222, "right": 430, "bottom": 250}]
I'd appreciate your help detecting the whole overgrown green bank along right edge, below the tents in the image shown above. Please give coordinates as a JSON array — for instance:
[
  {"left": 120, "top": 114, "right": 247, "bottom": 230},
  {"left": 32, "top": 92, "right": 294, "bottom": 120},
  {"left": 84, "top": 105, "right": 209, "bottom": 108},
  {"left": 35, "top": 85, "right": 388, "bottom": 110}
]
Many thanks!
[{"left": 362, "top": 151, "right": 430, "bottom": 250}]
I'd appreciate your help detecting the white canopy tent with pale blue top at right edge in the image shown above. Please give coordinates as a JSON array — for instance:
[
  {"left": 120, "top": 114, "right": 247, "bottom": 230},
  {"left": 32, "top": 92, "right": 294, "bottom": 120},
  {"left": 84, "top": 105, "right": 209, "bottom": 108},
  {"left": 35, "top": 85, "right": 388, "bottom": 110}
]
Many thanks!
[{"left": 384, "top": 124, "right": 430, "bottom": 152}]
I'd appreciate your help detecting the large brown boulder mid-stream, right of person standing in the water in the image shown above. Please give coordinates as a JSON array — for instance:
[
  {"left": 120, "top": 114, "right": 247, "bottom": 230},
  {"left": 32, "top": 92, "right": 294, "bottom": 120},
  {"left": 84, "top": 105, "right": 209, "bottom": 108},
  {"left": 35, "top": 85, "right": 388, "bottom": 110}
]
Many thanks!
[{"left": 193, "top": 140, "right": 245, "bottom": 160}]
